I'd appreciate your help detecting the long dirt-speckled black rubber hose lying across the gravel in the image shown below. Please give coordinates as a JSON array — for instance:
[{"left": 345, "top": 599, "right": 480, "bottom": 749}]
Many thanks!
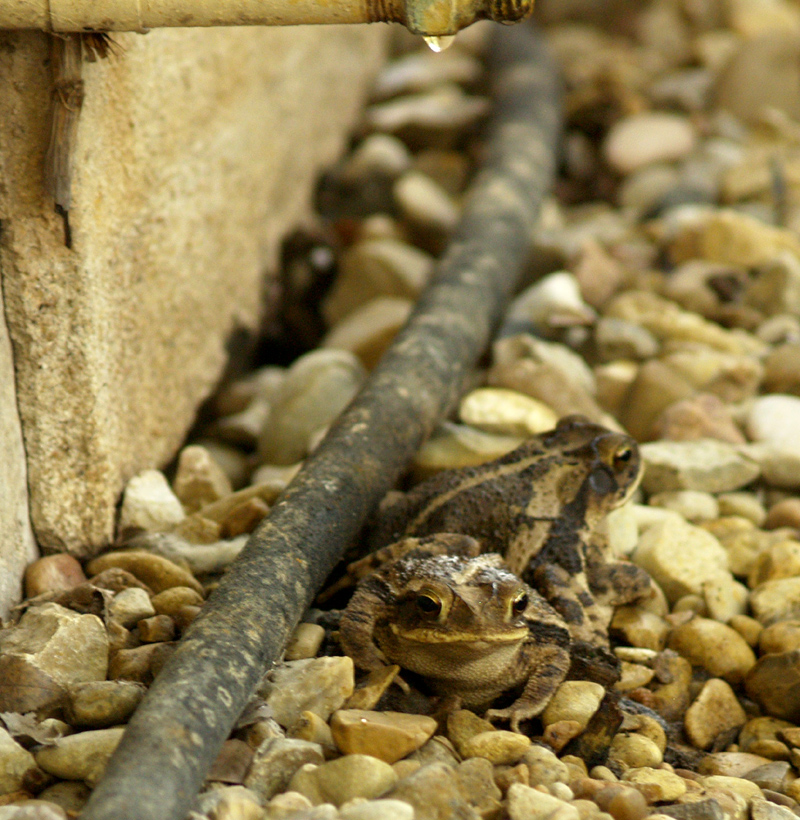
[{"left": 82, "top": 25, "right": 560, "bottom": 820}]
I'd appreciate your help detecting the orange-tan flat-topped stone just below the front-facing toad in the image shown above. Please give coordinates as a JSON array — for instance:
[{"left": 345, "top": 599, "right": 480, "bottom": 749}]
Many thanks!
[{"left": 330, "top": 709, "right": 436, "bottom": 763}]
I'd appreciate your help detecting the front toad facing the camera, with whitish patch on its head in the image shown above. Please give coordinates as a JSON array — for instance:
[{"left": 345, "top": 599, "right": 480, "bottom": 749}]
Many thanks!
[{"left": 340, "top": 533, "right": 570, "bottom": 731}]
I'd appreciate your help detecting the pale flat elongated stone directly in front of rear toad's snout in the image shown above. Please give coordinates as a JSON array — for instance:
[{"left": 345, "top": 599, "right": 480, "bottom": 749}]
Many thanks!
[{"left": 641, "top": 439, "right": 760, "bottom": 494}]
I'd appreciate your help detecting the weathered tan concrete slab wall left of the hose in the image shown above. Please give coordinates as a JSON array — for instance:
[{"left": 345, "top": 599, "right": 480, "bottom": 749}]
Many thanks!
[{"left": 0, "top": 26, "right": 389, "bottom": 572}]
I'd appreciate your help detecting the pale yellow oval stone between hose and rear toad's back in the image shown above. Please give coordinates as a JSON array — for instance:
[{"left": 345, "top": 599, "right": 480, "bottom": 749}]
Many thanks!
[{"left": 458, "top": 387, "right": 558, "bottom": 437}]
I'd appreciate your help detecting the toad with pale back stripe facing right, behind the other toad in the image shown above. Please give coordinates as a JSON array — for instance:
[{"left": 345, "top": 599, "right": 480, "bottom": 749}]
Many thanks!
[{"left": 369, "top": 416, "right": 649, "bottom": 682}]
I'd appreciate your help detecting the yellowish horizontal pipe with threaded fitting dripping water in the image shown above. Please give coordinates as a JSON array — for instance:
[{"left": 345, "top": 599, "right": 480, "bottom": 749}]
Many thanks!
[{"left": 0, "top": 0, "right": 534, "bottom": 37}]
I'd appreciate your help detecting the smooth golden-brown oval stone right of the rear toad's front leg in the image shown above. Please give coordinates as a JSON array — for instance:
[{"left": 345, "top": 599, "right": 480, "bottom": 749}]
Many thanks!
[{"left": 668, "top": 618, "right": 756, "bottom": 684}]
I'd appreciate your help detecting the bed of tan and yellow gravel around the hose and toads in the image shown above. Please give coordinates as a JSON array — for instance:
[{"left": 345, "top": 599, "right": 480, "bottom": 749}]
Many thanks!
[{"left": 0, "top": 0, "right": 800, "bottom": 820}]
